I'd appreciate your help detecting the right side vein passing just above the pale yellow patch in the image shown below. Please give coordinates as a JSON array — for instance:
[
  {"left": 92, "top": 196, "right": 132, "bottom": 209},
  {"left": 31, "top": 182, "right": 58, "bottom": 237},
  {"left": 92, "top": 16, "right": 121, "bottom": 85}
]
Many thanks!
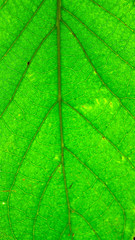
[{"left": 61, "top": 19, "right": 135, "bottom": 120}]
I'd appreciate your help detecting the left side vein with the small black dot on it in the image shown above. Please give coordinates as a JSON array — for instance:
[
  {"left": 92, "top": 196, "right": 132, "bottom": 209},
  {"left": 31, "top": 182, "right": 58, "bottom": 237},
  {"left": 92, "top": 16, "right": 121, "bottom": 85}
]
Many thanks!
[{"left": 0, "top": 26, "right": 56, "bottom": 118}]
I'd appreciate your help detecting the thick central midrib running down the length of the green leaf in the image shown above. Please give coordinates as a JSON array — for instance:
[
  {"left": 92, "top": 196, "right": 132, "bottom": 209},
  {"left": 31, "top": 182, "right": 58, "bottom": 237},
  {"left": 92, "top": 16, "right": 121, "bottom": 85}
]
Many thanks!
[{"left": 57, "top": 0, "right": 72, "bottom": 234}]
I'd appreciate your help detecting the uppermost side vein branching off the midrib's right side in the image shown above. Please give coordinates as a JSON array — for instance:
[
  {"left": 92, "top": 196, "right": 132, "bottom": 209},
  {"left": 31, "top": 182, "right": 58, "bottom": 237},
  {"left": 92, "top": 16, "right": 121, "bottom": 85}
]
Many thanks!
[{"left": 62, "top": 7, "right": 135, "bottom": 69}]
